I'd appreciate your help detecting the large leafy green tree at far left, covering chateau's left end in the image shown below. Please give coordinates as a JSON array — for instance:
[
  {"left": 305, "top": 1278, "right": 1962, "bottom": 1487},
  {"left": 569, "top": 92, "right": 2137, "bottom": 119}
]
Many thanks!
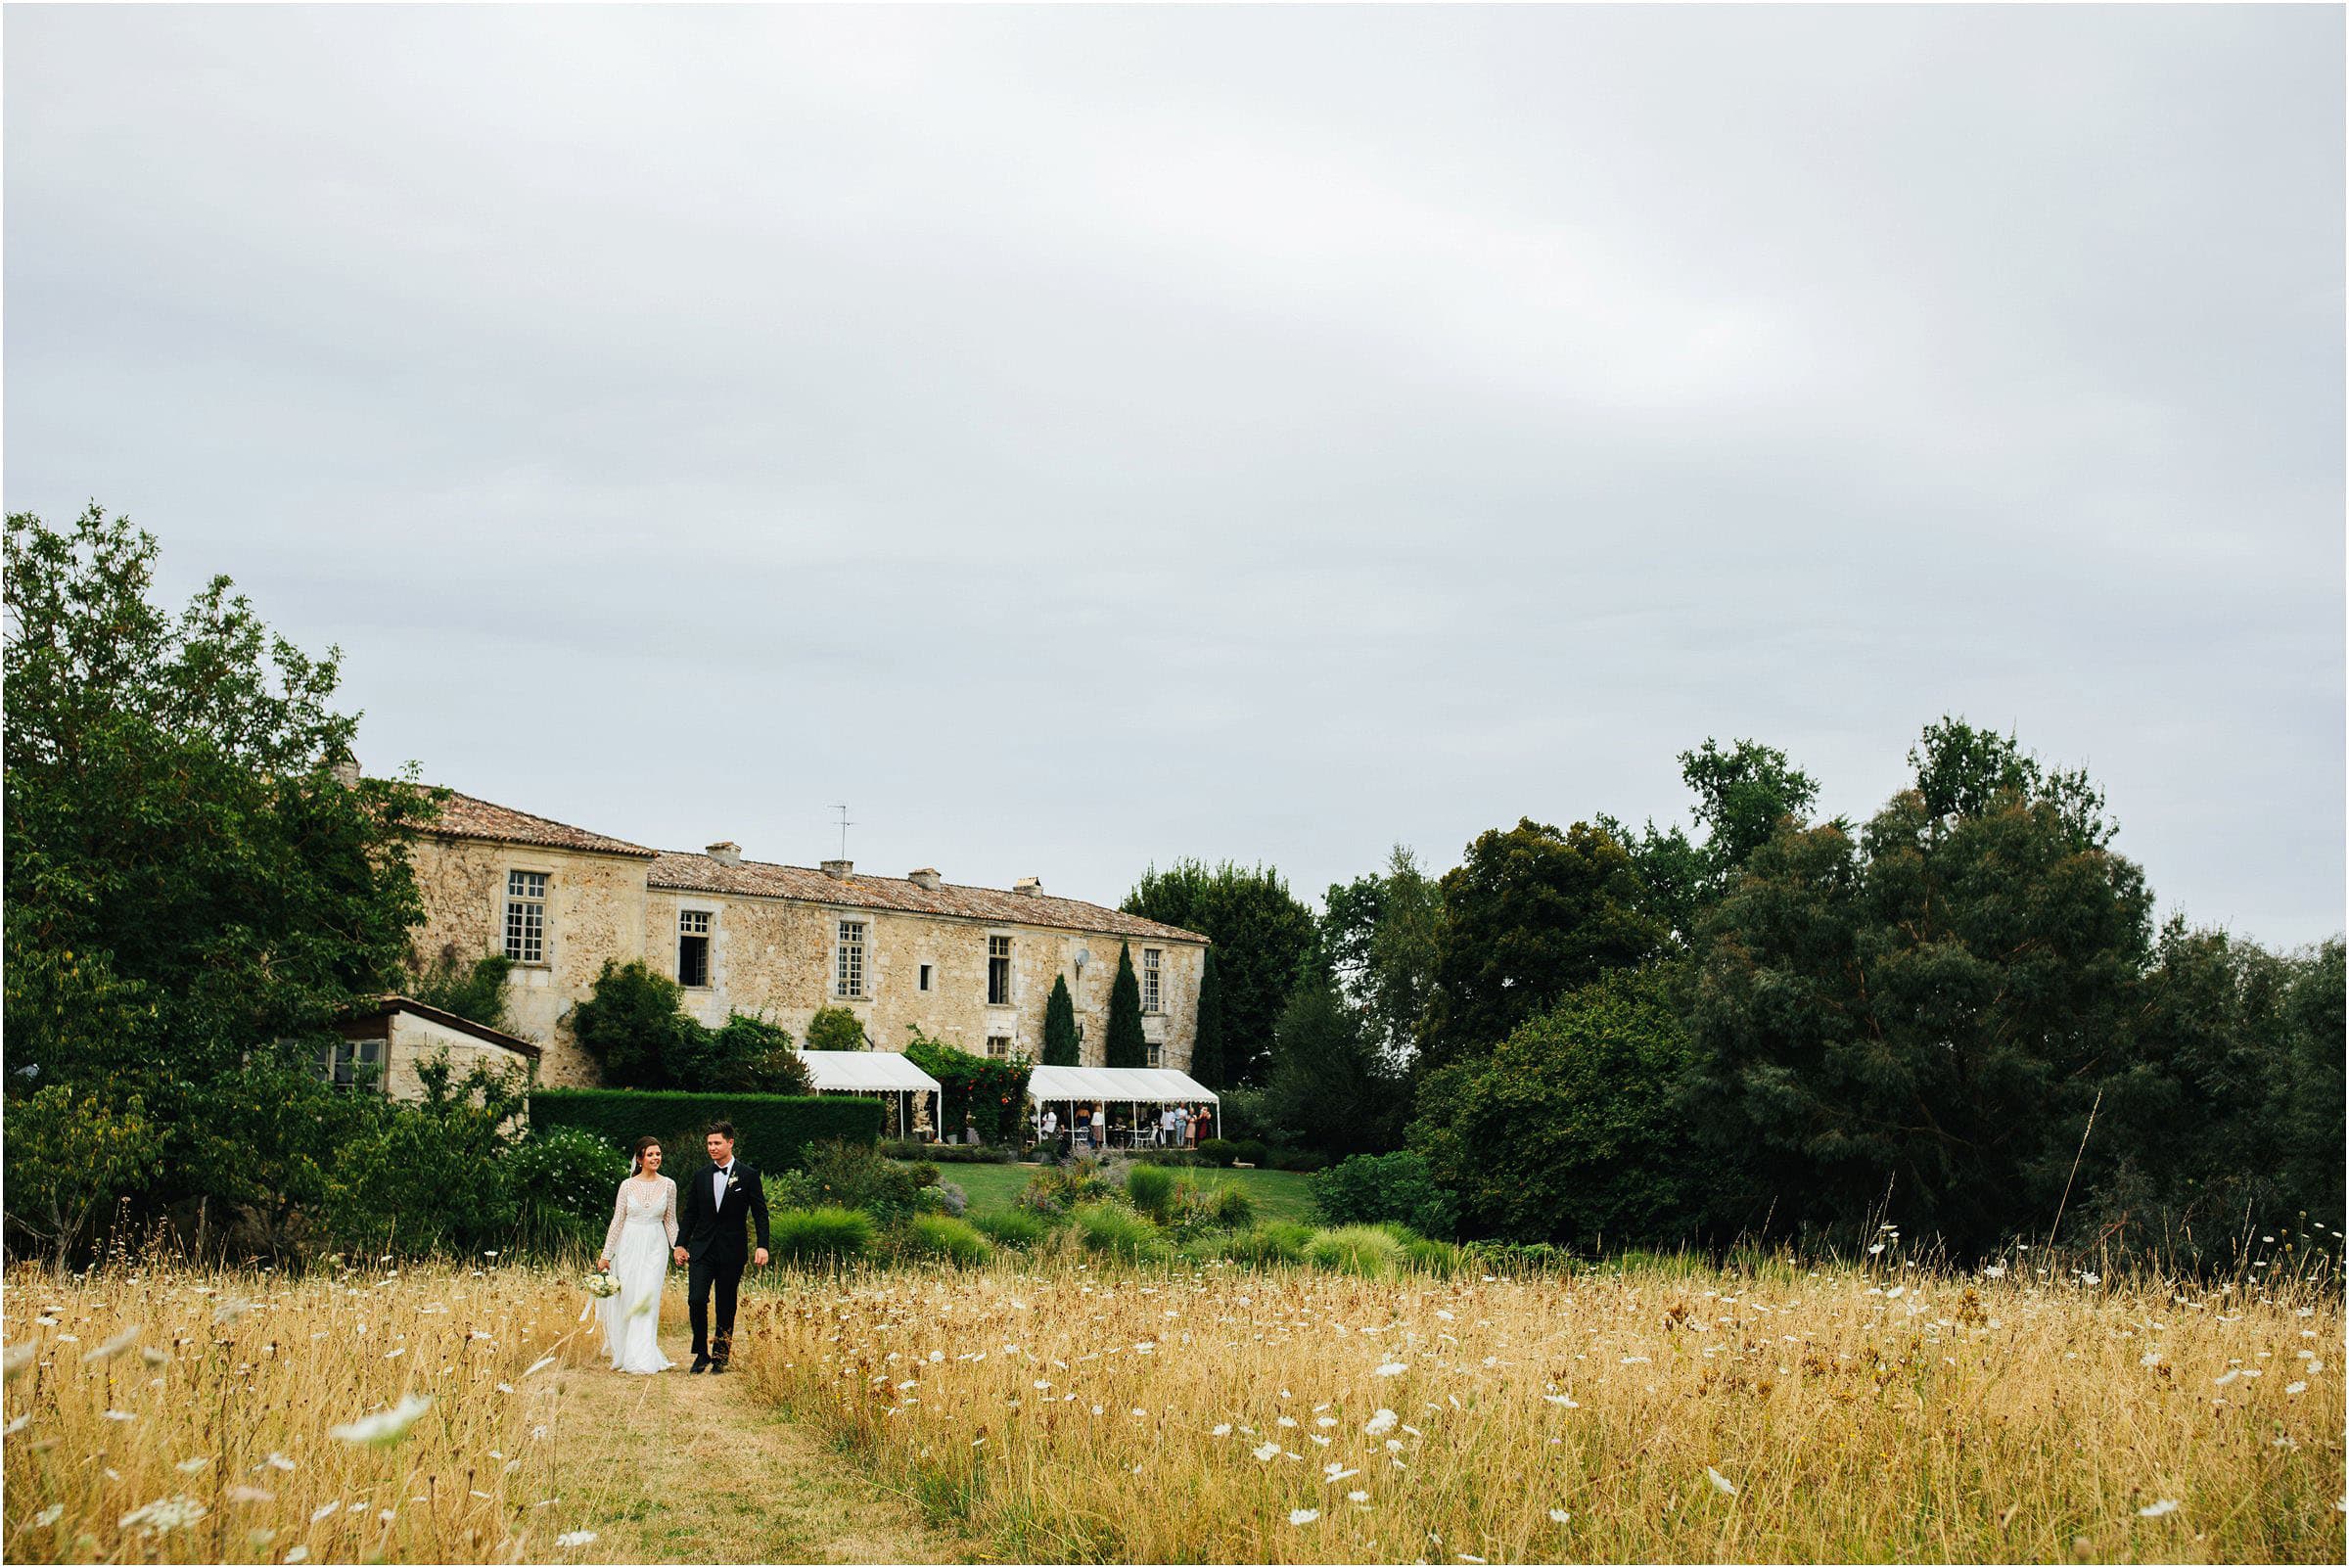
[{"left": 0, "top": 507, "right": 437, "bottom": 1258}]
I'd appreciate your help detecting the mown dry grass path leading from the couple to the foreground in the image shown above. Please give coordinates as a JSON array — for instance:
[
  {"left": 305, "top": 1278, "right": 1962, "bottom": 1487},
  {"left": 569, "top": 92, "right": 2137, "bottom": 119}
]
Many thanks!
[{"left": 524, "top": 1291, "right": 977, "bottom": 1563}]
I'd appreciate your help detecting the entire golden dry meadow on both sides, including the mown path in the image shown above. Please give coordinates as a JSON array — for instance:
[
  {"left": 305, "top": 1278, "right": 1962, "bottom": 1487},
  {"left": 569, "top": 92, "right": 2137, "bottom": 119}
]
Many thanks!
[{"left": 0, "top": 1256, "right": 2344, "bottom": 1563}]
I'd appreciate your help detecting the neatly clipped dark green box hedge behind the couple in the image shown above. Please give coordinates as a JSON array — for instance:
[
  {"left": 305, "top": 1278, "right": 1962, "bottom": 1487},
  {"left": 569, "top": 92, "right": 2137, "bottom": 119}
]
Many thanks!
[{"left": 530, "top": 1089, "right": 881, "bottom": 1176}]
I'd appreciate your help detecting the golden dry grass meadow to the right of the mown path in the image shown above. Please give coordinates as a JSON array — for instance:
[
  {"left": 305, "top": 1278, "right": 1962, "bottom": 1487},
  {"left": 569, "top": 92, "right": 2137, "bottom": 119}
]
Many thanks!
[{"left": 750, "top": 1261, "right": 2344, "bottom": 1563}]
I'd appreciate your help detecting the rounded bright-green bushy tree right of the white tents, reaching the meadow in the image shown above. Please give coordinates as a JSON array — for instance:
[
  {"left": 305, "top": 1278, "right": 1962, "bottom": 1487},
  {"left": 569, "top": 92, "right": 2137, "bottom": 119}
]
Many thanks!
[{"left": 1409, "top": 969, "right": 1710, "bottom": 1246}]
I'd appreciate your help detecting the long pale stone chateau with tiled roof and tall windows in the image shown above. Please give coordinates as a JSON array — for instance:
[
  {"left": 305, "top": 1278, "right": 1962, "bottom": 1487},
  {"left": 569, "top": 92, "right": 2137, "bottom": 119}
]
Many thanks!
[{"left": 413, "top": 796, "right": 1208, "bottom": 1084}]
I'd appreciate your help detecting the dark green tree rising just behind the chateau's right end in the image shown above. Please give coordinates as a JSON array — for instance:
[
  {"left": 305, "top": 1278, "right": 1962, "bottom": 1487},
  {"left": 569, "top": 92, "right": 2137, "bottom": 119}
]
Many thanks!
[{"left": 1121, "top": 859, "right": 1315, "bottom": 1084}]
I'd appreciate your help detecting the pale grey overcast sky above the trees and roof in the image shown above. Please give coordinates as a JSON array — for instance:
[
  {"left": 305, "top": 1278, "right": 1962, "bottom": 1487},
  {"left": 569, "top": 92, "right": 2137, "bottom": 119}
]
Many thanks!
[{"left": 5, "top": 7, "right": 2344, "bottom": 944}]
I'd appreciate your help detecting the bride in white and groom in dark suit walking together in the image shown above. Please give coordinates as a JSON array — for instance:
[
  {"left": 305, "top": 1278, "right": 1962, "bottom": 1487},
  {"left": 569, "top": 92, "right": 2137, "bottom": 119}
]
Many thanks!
[{"left": 597, "top": 1122, "right": 765, "bottom": 1373}]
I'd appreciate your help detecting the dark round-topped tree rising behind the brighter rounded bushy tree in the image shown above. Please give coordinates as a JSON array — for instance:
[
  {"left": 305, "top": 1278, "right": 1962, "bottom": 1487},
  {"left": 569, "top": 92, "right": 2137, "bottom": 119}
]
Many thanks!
[{"left": 1421, "top": 817, "right": 1666, "bottom": 1066}]
